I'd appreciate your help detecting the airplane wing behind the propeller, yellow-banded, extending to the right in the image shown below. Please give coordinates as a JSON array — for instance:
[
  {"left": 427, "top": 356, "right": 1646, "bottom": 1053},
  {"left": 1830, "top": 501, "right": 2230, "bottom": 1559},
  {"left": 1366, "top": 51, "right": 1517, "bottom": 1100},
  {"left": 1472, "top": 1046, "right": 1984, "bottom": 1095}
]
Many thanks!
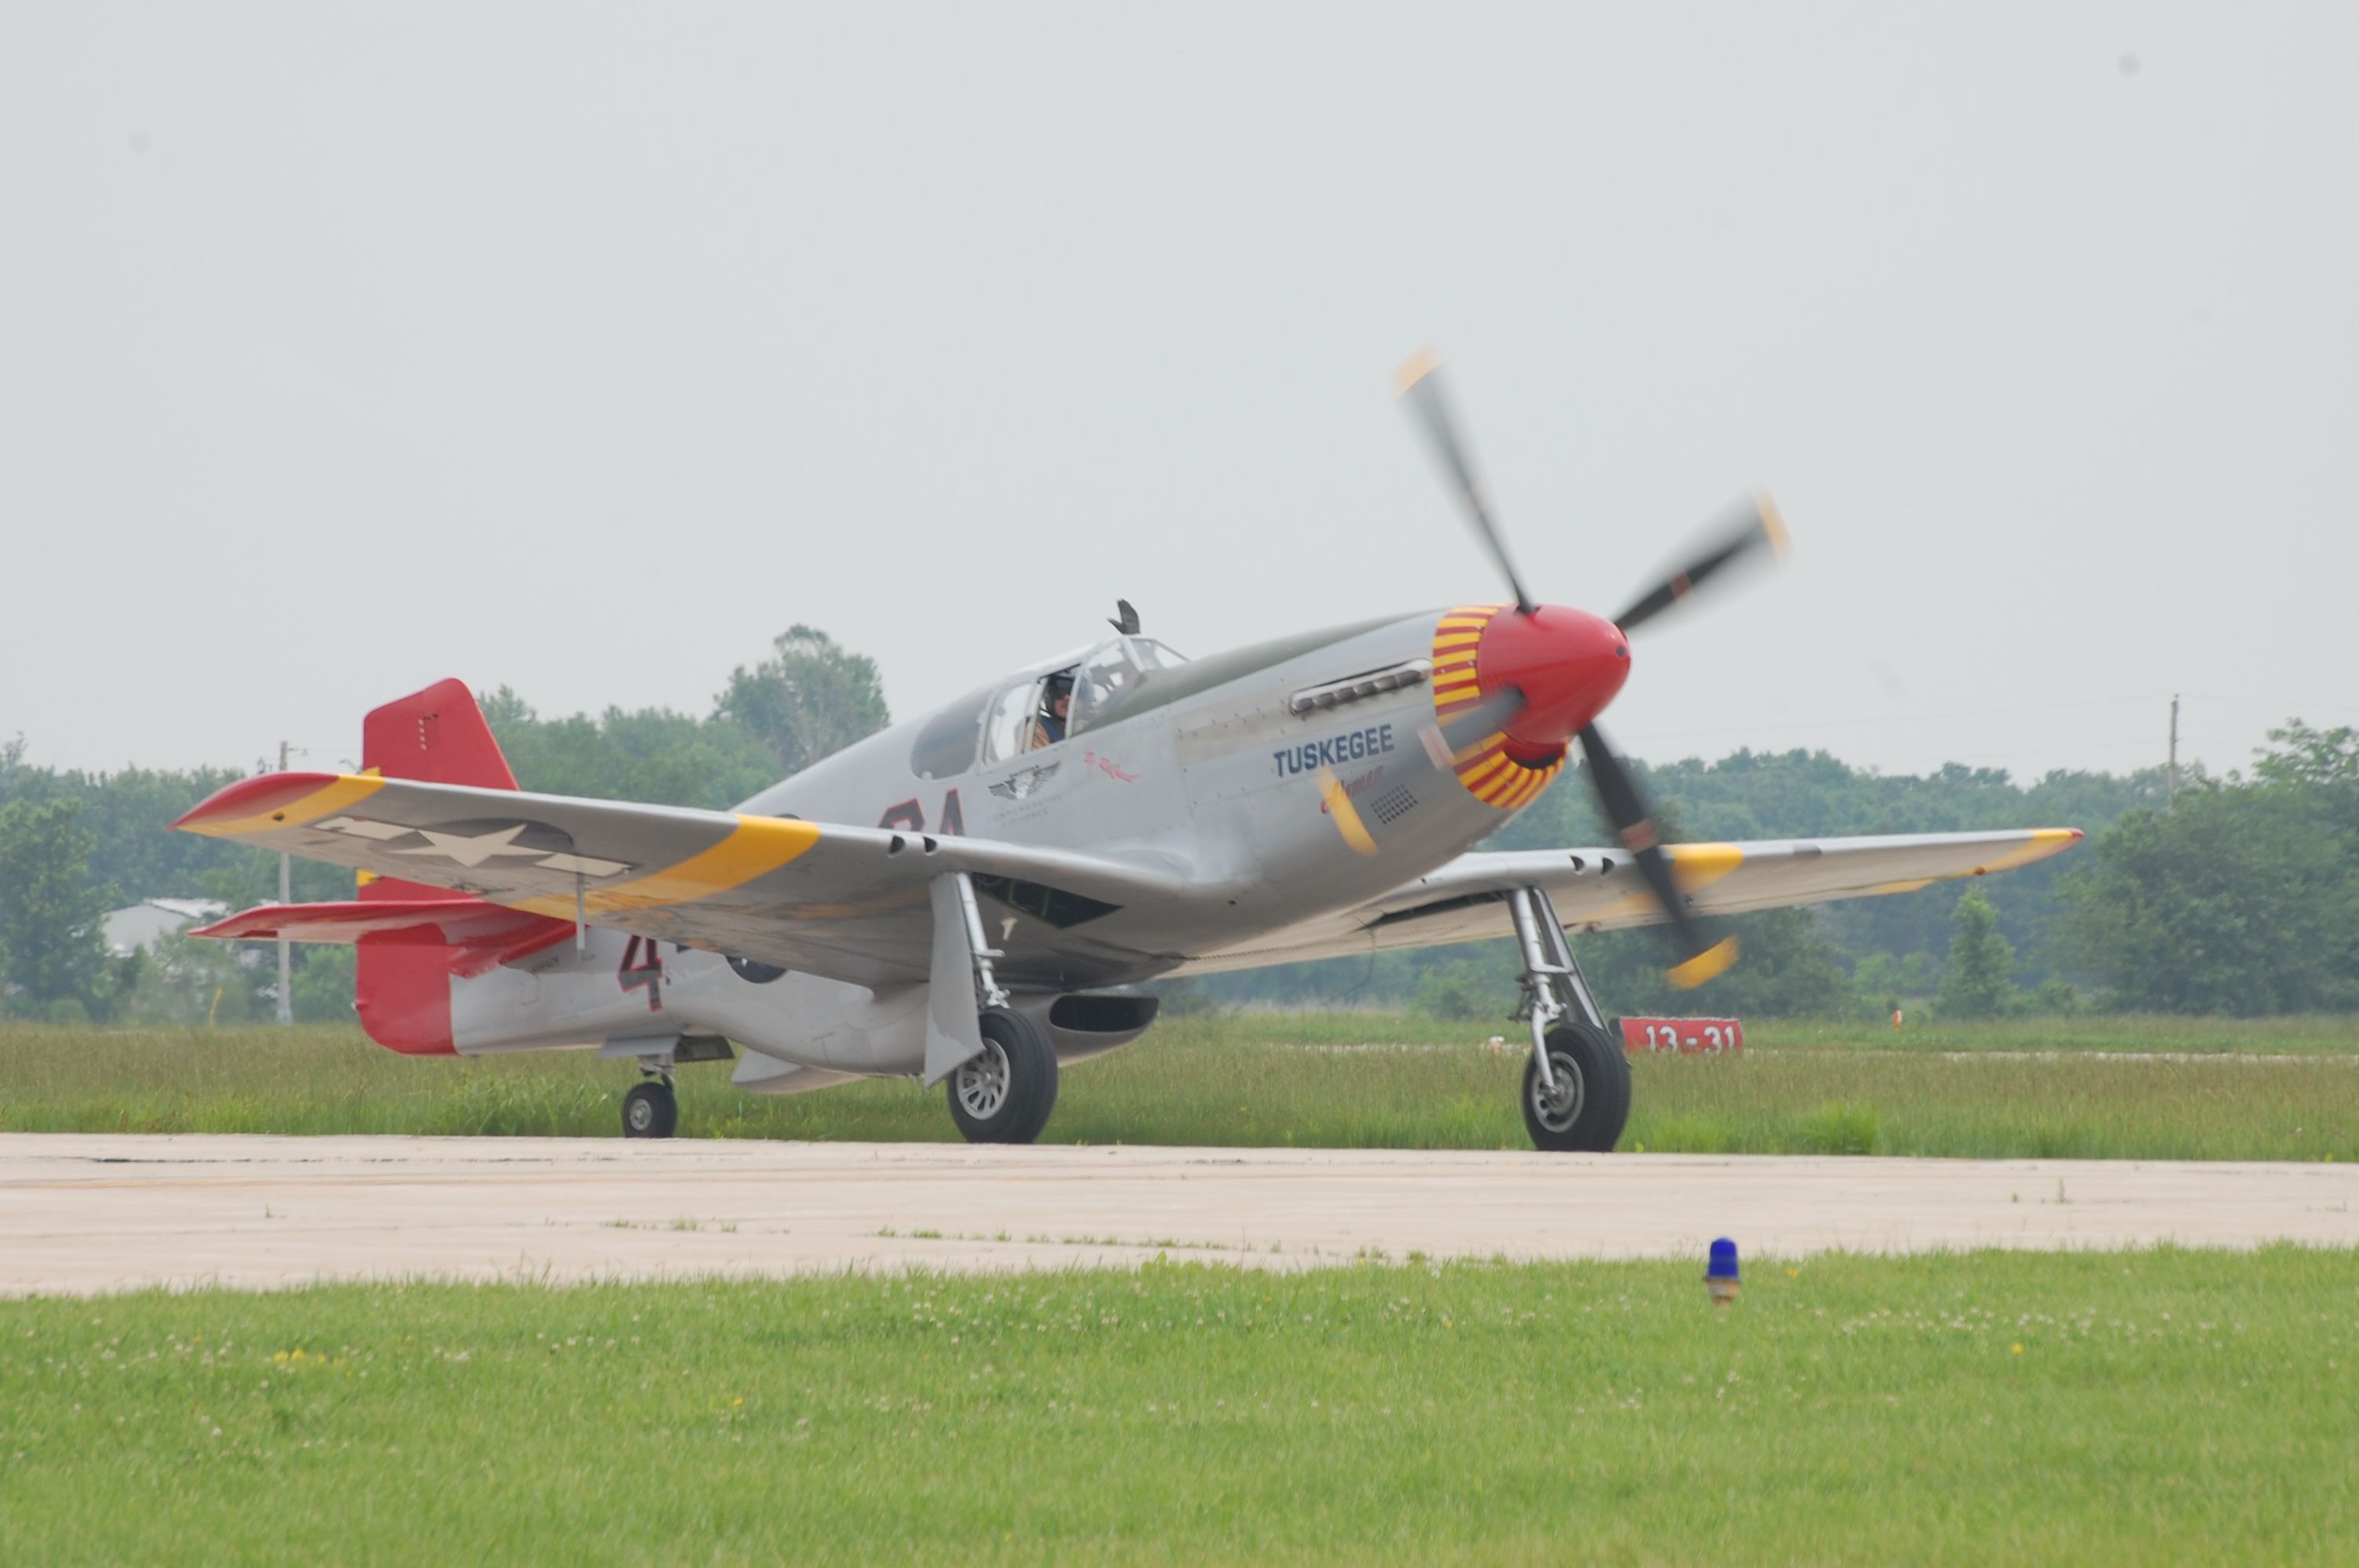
[{"left": 1184, "top": 828, "right": 2081, "bottom": 974}]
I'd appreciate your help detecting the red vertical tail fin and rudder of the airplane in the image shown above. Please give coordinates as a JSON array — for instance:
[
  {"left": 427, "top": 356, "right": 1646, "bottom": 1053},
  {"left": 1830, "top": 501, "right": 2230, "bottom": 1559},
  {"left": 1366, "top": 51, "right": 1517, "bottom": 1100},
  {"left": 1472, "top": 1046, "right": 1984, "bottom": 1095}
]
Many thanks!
[{"left": 354, "top": 681, "right": 517, "bottom": 1056}]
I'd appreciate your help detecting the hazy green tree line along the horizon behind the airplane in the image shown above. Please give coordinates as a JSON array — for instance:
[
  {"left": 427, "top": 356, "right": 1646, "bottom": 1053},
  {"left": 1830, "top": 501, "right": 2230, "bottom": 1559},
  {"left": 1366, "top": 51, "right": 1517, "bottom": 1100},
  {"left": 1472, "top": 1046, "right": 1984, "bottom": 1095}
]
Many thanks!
[{"left": 0, "top": 625, "right": 2359, "bottom": 1023}]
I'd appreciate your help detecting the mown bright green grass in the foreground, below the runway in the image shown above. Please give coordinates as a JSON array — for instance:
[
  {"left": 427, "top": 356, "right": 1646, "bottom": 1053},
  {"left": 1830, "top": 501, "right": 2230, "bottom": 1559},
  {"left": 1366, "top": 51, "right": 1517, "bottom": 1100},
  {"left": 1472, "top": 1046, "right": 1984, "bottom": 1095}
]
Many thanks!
[{"left": 0, "top": 1247, "right": 2359, "bottom": 1563}]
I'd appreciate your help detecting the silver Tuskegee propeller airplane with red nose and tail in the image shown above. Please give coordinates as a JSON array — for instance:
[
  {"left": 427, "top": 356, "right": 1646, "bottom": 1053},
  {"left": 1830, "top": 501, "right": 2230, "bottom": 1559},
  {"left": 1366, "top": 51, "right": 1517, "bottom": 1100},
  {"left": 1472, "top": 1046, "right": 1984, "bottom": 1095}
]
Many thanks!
[{"left": 175, "top": 356, "right": 2081, "bottom": 1151}]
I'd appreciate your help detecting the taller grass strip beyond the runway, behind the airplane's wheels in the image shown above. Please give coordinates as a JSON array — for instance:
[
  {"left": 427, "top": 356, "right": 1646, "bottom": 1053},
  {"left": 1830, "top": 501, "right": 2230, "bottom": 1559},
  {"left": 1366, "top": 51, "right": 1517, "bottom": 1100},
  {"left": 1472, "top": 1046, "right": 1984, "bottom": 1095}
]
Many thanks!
[{"left": 0, "top": 1014, "right": 2359, "bottom": 1160}]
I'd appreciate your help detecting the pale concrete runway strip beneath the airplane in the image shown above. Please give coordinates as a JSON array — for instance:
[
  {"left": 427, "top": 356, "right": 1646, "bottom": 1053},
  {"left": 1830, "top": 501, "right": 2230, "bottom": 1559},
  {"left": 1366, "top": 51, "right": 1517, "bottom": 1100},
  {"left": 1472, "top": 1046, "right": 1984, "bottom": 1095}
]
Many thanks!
[{"left": 0, "top": 1132, "right": 2359, "bottom": 1294}]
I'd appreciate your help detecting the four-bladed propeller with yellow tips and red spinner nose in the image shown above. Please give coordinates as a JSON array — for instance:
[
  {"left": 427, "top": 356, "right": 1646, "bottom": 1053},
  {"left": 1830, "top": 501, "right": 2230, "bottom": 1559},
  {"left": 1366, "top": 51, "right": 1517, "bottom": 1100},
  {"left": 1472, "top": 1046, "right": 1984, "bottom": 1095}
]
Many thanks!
[{"left": 1399, "top": 351, "right": 1786, "bottom": 988}]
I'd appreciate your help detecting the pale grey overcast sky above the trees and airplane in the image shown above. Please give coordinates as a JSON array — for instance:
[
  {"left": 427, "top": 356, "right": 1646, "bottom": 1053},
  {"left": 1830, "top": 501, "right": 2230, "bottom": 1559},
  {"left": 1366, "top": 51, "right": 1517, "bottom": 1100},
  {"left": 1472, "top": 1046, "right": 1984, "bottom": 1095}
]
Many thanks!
[{"left": 0, "top": 0, "right": 2359, "bottom": 775}]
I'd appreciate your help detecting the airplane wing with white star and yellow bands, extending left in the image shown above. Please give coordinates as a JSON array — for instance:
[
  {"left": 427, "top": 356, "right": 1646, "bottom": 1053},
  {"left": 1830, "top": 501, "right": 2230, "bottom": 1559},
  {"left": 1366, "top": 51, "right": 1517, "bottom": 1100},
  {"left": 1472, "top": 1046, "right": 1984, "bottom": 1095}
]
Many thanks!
[{"left": 173, "top": 773, "right": 1184, "bottom": 985}]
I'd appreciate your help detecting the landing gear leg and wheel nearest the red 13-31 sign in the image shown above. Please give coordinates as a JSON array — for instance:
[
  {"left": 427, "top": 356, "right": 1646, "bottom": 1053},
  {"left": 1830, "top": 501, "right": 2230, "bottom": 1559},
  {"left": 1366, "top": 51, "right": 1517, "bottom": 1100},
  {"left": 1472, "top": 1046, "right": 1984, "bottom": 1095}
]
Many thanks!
[{"left": 1507, "top": 887, "right": 1630, "bottom": 1153}]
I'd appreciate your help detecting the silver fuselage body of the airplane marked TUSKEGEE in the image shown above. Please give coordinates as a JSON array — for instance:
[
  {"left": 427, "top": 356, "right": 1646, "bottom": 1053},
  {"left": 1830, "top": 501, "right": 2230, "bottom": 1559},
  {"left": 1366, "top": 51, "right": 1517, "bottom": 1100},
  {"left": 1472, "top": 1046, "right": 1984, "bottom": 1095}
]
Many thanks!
[{"left": 453, "top": 611, "right": 1512, "bottom": 1091}]
